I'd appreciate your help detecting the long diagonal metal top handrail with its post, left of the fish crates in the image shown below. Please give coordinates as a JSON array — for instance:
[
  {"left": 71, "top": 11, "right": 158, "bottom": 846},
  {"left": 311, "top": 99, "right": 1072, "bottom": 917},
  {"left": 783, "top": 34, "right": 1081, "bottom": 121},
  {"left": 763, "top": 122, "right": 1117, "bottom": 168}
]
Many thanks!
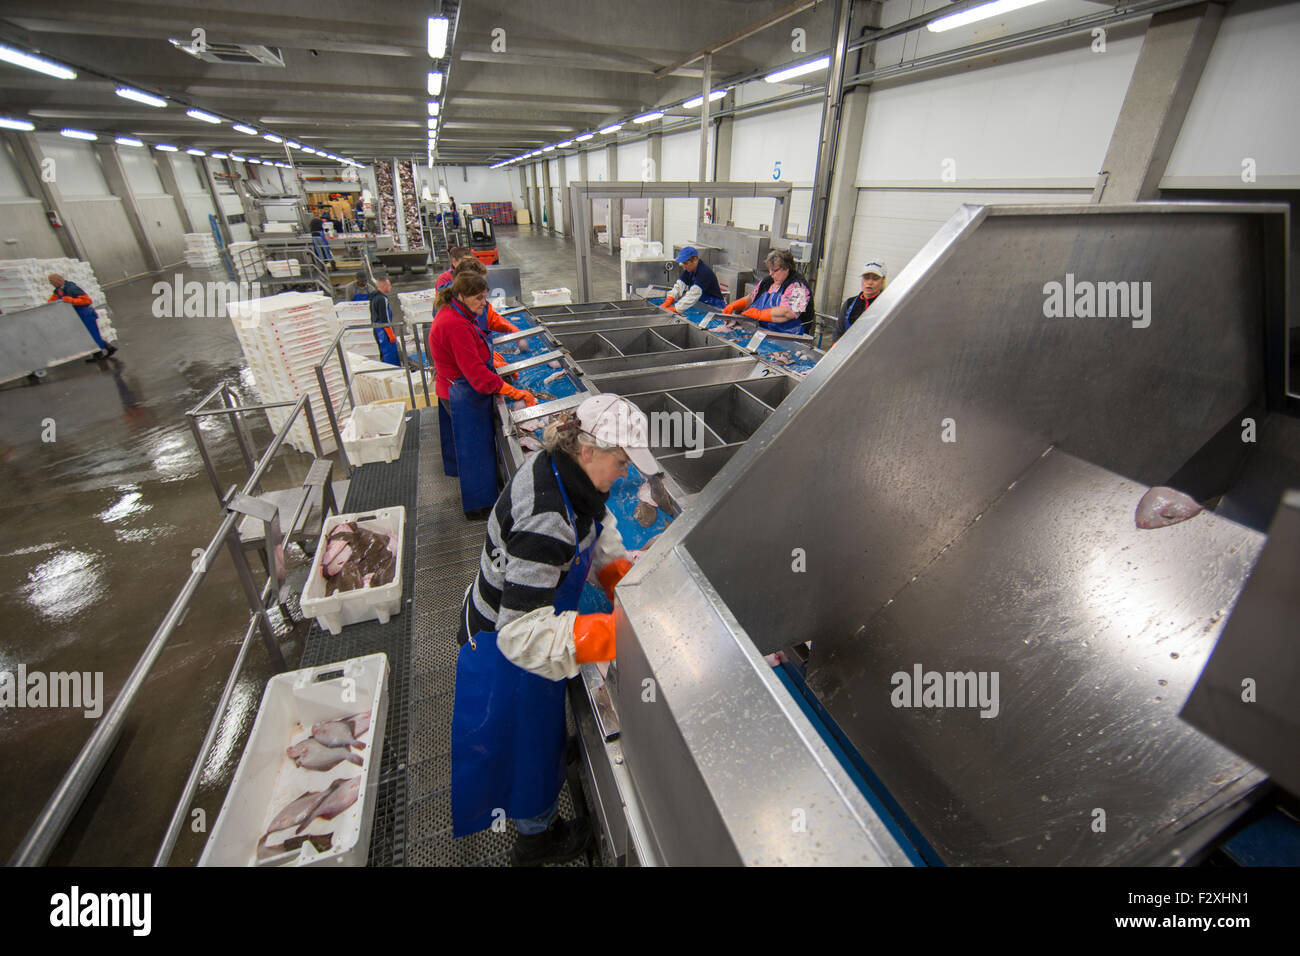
[{"left": 9, "top": 386, "right": 320, "bottom": 866}]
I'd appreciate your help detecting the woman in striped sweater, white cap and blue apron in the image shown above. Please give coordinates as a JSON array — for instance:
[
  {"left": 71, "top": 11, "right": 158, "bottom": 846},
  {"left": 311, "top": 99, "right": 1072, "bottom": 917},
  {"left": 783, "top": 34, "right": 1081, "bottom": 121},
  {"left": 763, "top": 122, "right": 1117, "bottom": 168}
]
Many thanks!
[{"left": 451, "top": 394, "right": 659, "bottom": 865}]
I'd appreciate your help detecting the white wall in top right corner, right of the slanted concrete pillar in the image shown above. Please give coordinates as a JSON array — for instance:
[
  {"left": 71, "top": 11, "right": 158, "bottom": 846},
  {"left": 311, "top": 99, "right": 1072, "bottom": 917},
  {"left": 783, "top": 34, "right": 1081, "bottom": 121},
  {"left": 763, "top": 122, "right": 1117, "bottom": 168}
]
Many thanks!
[{"left": 1160, "top": 0, "right": 1300, "bottom": 189}]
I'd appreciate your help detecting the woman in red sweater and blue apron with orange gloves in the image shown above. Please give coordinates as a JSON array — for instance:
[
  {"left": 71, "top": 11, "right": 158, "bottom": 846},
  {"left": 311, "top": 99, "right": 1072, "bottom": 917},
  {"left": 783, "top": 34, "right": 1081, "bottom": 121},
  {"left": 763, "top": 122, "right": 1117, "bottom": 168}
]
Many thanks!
[{"left": 429, "top": 273, "right": 537, "bottom": 519}]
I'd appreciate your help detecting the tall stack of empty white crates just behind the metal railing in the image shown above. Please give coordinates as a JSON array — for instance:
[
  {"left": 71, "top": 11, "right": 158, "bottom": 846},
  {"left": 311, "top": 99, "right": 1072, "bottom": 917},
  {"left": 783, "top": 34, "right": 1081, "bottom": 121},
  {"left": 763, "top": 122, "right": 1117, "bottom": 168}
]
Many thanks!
[{"left": 226, "top": 293, "right": 346, "bottom": 453}]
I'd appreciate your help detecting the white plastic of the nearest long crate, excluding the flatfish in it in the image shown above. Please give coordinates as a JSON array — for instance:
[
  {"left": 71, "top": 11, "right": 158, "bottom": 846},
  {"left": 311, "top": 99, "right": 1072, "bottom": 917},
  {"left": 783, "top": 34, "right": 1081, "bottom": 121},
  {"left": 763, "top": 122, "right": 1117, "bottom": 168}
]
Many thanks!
[{"left": 199, "top": 654, "right": 389, "bottom": 866}]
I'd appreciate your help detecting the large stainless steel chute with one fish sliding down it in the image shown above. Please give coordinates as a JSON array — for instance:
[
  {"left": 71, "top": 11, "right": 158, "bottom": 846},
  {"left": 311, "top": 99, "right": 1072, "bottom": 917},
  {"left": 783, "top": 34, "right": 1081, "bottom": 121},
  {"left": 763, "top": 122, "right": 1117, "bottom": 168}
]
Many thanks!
[{"left": 602, "top": 203, "right": 1300, "bottom": 865}]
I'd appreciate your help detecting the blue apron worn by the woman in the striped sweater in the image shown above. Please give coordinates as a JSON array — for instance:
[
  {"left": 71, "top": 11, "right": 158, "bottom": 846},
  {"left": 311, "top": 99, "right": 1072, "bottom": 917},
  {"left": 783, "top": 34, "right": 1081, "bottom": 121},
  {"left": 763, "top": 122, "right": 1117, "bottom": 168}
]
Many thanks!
[{"left": 451, "top": 460, "right": 590, "bottom": 836}]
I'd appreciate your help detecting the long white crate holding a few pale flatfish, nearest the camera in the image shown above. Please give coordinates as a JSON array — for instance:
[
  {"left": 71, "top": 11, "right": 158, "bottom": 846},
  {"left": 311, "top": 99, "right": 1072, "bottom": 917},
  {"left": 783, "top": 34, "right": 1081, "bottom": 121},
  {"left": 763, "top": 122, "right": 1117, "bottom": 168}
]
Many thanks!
[{"left": 199, "top": 654, "right": 389, "bottom": 866}]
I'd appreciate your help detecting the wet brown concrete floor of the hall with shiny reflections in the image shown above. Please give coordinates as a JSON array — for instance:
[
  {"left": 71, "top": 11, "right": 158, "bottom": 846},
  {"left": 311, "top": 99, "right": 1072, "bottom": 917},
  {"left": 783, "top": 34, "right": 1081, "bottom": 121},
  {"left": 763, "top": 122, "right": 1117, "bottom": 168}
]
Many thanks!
[{"left": 0, "top": 226, "right": 619, "bottom": 866}]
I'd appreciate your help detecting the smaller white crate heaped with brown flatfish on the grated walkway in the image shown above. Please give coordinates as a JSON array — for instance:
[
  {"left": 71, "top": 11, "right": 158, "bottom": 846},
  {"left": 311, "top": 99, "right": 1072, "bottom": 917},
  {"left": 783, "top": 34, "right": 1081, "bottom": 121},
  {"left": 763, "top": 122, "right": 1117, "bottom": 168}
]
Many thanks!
[{"left": 302, "top": 506, "right": 406, "bottom": 633}]
